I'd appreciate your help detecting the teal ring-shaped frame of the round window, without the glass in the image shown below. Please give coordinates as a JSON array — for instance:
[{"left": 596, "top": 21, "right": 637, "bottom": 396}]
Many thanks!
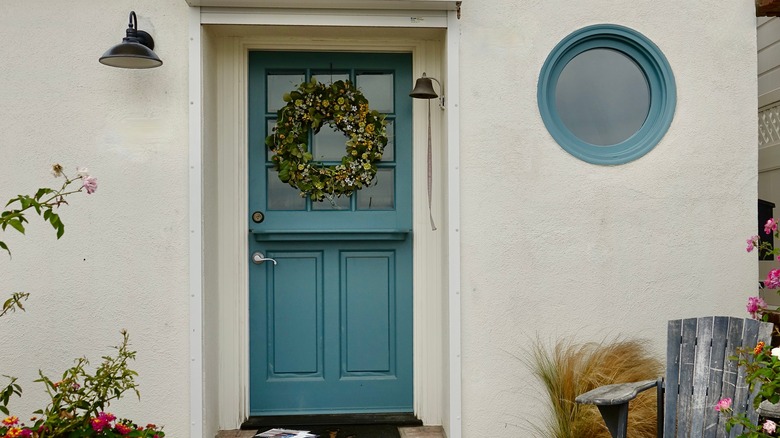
[{"left": 537, "top": 24, "right": 677, "bottom": 165}]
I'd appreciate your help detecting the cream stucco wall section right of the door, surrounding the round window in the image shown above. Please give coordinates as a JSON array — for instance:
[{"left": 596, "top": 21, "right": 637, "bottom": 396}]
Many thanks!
[{"left": 460, "top": 0, "right": 757, "bottom": 437}]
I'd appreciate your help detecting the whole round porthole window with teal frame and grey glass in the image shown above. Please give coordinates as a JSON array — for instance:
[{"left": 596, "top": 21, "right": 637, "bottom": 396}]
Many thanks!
[{"left": 538, "top": 24, "right": 677, "bottom": 165}]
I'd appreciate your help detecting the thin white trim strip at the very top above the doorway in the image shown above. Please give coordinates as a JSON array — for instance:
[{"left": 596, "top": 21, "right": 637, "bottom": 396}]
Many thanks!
[{"left": 186, "top": 0, "right": 460, "bottom": 11}]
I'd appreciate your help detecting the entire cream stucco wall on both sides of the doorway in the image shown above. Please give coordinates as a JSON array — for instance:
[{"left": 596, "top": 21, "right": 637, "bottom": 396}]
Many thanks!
[{"left": 0, "top": 0, "right": 757, "bottom": 437}]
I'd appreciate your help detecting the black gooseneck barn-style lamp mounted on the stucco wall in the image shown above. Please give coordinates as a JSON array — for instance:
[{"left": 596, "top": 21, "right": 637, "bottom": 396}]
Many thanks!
[{"left": 100, "top": 11, "right": 162, "bottom": 68}]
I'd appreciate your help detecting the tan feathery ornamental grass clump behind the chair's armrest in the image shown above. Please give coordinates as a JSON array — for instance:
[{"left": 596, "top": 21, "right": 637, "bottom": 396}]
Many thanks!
[{"left": 529, "top": 340, "right": 663, "bottom": 438}]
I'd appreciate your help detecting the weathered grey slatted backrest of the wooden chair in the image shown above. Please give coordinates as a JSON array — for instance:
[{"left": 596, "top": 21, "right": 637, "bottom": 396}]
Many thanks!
[{"left": 663, "top": 316, "right": 772, "bottom": 438}]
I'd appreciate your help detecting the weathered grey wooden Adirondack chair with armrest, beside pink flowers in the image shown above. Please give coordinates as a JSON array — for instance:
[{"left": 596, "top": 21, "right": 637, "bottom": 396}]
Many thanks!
[{"left": 576, "top": 316, "right": 772, "bottom": 438}]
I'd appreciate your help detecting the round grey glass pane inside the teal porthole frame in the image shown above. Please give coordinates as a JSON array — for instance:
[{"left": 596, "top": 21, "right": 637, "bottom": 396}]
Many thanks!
[{"left": 555, "top": 49, "right": 650, "bottom": 146}]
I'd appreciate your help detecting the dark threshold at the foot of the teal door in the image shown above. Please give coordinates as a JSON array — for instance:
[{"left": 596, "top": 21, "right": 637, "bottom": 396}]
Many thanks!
[{"left": 241, "top": 412, "right": 422, "bottom": 430}]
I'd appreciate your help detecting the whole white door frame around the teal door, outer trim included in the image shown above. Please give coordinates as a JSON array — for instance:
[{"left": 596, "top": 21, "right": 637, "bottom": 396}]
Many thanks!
[{"left": 189, "top": 7, "right": 461, "bottom": 438}]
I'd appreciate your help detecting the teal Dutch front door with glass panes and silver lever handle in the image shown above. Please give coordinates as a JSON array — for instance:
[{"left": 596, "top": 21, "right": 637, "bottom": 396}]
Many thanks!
[{"left": 248, "top": 52, "right": 413, "bottom": 415}]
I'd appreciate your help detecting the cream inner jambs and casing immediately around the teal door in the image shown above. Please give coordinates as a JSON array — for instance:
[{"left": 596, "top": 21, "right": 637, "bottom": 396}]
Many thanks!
[{"left": 207, "top": 29, "right": 450, "bottom": 428}]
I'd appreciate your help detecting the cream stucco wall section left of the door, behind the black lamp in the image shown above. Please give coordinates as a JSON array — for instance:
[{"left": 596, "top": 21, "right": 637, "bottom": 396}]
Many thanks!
[{"left": 0, "top": 0, "right": 189, "bottom": 437}]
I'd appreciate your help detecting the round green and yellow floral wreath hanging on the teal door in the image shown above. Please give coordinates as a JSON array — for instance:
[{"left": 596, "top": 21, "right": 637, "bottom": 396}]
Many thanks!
[{"left": 265, "top": 78, "right": 387, "bottom": 201}]
